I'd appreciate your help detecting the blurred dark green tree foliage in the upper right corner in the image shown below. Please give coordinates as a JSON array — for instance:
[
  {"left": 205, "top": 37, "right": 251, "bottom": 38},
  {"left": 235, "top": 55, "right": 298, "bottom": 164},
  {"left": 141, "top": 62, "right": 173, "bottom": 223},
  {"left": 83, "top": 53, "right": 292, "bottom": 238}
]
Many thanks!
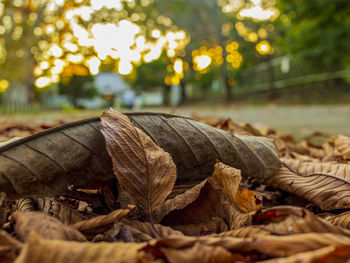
[{"left": 276, "top": 0, "right": 350, "bottom": 71}]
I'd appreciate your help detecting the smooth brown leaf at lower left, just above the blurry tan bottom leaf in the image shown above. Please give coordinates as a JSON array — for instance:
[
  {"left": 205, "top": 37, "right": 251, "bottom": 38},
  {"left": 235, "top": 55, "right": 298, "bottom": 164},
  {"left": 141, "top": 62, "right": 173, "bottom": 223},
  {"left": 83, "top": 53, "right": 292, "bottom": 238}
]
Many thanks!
[{"left": 12, "top": 211, "right": 86, "bottom": 242}]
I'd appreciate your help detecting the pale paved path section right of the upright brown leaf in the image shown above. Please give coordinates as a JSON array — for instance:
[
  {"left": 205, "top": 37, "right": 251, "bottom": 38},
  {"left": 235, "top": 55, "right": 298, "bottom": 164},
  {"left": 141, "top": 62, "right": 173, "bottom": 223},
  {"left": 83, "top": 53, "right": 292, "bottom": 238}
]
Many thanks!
[{"left": 148, "top": 105, "right": 350, "bottom": 138}]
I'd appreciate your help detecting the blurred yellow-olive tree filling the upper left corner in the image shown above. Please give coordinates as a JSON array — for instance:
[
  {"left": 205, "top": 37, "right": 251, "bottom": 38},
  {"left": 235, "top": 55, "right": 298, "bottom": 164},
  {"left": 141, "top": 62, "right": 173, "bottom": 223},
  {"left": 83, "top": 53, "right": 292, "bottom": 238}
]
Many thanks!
[{"left": 0, "top": 0, "right": 91, "bottom": 102}]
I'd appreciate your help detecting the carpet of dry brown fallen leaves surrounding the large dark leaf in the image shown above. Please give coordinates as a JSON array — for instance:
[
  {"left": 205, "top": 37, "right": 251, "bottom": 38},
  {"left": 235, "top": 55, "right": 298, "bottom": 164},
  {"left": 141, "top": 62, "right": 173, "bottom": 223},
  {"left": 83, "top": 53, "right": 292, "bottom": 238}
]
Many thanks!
[{"left": 0, "top": 110, "right": 350, "bottom": 263}]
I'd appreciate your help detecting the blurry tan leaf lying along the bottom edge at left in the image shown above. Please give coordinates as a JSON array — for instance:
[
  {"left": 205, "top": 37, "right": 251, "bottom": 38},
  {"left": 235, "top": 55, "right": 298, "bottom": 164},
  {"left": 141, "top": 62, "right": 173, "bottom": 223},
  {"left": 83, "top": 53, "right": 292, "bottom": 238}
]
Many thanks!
[{"left": 15, "top": 234, "right": 144, "bottom": 263}]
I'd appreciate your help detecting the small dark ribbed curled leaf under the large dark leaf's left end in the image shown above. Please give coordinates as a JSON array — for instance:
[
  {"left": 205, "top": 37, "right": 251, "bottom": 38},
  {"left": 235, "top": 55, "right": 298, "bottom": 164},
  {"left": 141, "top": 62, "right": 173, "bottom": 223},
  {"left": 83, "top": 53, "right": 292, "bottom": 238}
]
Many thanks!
[{"left": 16, "top": 197, "right": 92, "bottom": 225}]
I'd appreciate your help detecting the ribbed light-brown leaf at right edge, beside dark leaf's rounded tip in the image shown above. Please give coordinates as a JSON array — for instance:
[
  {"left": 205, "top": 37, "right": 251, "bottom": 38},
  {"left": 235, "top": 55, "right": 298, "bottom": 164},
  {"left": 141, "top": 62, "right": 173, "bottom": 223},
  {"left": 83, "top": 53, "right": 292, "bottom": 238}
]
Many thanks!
[{"left": 266, "top": 158, "right": 350, "bottom": 210}]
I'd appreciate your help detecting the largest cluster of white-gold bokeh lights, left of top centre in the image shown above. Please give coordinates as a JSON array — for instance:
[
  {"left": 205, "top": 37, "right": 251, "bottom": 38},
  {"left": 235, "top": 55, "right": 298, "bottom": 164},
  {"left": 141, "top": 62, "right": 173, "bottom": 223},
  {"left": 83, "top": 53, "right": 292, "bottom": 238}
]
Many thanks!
[{"left": 21, "top": 0, "right": 190, "bottom": 88}]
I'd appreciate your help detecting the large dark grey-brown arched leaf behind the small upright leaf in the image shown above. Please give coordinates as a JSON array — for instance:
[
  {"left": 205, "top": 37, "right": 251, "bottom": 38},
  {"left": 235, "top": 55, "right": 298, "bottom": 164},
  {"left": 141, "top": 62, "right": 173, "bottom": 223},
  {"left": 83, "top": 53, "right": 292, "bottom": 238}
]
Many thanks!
[{"left": 0, "top": 113, "right": 280, "bottom": 198}]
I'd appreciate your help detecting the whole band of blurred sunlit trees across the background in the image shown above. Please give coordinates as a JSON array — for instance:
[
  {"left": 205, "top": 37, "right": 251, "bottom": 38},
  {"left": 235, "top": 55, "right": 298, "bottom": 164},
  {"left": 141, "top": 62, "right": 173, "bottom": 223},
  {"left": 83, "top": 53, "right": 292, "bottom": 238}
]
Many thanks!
[{"left": 0, "top": 0, "right": 350, "bottom": 110}]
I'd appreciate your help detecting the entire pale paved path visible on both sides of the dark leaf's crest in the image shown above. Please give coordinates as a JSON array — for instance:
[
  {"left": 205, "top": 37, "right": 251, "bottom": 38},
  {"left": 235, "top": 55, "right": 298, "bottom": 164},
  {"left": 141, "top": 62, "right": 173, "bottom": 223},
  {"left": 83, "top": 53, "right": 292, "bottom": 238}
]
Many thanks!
[{"left": 0, "top": 104, "right": 350, "bottom": 138}]
